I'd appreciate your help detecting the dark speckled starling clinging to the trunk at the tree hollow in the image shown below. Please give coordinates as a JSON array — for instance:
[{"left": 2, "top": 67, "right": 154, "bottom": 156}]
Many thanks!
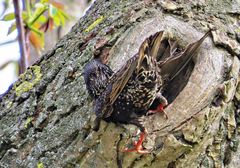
[{"left": 83, "top": 31, "right": 210, "bottom": 153}]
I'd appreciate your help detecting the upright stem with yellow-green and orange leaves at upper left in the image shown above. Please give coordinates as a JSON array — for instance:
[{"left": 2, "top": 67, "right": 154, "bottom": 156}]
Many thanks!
[{"left": 2, "top": 0, "right": 69, "bottom": 73}]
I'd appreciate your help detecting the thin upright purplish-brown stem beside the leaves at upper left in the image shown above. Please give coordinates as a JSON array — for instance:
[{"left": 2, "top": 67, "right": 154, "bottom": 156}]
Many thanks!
[{"left": 13, "top": 0, "right": 27, "bottom": 74}]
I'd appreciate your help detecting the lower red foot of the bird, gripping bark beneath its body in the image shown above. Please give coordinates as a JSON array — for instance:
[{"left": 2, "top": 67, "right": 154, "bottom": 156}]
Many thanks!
[{"left": 124, "top": 130, "right": 150, "bottom": 154}]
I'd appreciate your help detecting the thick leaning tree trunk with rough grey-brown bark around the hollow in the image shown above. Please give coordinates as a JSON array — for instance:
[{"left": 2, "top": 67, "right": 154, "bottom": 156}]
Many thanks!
[{"left": 0, "top": 0, "right": 240, "bottom": 168}]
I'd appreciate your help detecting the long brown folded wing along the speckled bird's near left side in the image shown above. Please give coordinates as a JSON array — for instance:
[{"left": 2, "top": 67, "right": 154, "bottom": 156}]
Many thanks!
[{"left": 95, "top": 31, "right": 163, "bottom": 118}]
